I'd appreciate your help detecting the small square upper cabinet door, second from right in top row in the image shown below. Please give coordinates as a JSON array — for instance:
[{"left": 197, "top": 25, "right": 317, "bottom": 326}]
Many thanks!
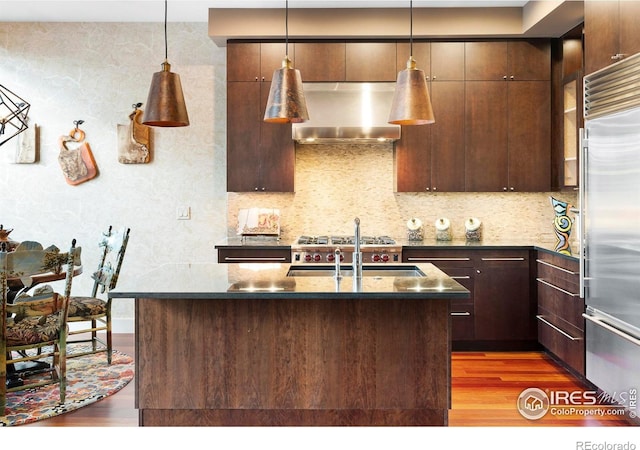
[{"left": 464, "top": 42, "right": 508, "bottom": 81}]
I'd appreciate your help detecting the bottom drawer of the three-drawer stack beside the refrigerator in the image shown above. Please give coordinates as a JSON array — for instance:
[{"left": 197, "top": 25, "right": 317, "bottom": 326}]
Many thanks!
[{"left": 536, "top": 309, "right": 585, "bottom": 376}]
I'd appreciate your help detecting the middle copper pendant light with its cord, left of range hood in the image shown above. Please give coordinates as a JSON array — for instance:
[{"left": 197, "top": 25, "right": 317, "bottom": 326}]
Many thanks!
[{"left": 264, "top": 0, "right": 309, "bottom": 123}]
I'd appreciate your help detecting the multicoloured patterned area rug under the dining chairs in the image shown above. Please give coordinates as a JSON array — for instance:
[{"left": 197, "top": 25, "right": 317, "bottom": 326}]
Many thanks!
[{"left": 0, "top": 350, "right": 134, "bottom": 427}]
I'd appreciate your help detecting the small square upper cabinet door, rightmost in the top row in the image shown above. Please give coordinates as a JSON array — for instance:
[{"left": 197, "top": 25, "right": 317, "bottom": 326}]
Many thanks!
[{"left": 507, "top": 40, "right": 551, "bottom": 81}]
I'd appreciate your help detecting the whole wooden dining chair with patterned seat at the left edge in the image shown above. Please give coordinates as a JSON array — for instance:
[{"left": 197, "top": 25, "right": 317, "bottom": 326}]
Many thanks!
[{"left": 0, "top": 239, "right": 80, "bottom": 415}]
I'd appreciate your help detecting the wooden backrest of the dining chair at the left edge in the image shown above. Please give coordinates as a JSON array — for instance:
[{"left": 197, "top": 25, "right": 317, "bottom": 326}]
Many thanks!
[{"left": 0, "top": 239, "right": 81, "bottom": 347}]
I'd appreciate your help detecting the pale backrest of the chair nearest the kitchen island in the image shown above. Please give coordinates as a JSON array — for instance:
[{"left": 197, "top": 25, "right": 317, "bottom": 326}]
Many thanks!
[{"left": 91, "top": 226, "right": 131, "bottom": 297}]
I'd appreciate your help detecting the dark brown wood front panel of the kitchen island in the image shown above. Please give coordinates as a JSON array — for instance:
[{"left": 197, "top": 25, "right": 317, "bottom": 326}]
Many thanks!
[{"left": 136, "top": 299, "right": 450, "bottom": 426}]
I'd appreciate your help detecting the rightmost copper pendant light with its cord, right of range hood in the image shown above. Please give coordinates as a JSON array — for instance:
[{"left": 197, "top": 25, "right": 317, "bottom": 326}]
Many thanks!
[{"left": 389, "top": 1, "right": 435, "bottom": 125}]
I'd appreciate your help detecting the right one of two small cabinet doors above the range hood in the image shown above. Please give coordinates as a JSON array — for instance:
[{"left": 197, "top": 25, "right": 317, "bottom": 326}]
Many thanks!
[{"left": 346, "top": 42, "right": 398, "bottom": 82}]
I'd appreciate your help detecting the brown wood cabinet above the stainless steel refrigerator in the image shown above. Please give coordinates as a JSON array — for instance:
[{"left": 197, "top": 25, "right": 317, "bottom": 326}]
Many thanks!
[{"left": 584, "top": 0, "right": 640, "bottom": 74}]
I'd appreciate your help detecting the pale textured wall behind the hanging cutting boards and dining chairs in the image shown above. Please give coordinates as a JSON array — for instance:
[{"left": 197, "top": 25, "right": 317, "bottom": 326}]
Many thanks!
[{"left": 0, "top": 23, "right": 227, "bottom": 326}]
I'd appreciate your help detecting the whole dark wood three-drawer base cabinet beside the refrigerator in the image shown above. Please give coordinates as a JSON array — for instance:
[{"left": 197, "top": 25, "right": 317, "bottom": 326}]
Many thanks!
[{"left": 536, "top": 251, "right": 585, "bottom": 376}]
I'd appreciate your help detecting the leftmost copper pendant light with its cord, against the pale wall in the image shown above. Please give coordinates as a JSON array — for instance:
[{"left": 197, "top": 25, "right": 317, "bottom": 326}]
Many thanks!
[{"left": 142, "top": 0, "right": 189, "bottom": 127}]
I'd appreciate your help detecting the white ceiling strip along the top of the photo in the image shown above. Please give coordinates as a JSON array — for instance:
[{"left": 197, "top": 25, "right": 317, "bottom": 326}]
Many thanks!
[{"left": 0, "top": 0, "right": 532, "bottom": 22}]
